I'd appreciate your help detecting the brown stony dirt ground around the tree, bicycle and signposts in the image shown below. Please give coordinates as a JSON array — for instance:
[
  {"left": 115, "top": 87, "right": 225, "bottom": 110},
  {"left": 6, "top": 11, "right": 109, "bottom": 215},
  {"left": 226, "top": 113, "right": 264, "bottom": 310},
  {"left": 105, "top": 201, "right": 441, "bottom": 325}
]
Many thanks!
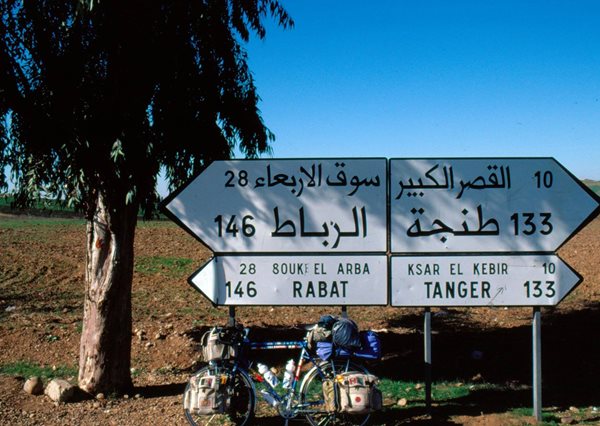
[{"left": 0, "top": 213, "right": 600, "bottom": 425}]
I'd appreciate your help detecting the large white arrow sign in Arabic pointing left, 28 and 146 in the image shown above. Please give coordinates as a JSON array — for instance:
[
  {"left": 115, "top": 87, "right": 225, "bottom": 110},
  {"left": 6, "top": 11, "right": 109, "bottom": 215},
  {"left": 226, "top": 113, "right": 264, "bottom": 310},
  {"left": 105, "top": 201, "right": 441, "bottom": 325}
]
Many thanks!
[{"left": 165, "top": 158, "right": 387, "bottom": 253}]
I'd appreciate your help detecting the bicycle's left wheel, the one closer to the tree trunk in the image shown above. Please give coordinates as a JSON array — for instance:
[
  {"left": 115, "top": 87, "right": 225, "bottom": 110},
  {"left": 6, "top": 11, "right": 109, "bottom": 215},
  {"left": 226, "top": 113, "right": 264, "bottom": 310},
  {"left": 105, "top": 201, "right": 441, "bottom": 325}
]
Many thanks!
[{"left": 183, "top": 365, "right": 256, "bottom": 426}]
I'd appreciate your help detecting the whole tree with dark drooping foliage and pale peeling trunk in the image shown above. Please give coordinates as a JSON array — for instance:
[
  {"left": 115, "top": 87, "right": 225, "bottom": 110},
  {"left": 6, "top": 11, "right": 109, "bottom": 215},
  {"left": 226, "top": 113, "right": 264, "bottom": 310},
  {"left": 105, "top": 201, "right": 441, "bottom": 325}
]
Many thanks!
[{"left": 0, "top": 0, "right": 293, "bottom": 393}]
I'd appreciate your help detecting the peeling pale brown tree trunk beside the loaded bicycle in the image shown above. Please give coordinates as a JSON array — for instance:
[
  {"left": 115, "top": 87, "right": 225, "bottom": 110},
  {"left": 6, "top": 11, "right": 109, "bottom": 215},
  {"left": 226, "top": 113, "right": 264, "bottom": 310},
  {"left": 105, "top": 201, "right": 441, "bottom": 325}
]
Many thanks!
[{"left": 79, "top": 195, "right": 137, "bottom": 394}]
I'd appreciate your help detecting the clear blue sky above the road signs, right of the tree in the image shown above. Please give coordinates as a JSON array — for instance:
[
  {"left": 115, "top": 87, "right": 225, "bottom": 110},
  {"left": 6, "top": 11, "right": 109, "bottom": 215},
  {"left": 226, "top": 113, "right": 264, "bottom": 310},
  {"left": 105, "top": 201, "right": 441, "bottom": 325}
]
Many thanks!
[{"left": 239, "top": 0, "right": 600, "bottom": 180}]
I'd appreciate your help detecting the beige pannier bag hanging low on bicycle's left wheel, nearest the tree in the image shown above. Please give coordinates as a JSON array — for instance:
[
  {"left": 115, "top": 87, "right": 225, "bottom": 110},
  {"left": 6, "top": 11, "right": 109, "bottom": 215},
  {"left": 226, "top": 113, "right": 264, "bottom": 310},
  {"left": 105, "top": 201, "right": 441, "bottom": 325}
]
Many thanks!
[{"left": 183, "top": 376, "right": 231, "bottom": 414}]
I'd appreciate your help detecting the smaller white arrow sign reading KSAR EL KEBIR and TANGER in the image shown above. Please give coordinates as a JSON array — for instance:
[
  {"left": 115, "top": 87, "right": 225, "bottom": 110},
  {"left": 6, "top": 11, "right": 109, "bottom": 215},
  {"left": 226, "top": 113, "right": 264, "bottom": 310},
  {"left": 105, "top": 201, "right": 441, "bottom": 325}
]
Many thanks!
[{"left": 391, "top": 255, "right": 581, "bottom": 306}]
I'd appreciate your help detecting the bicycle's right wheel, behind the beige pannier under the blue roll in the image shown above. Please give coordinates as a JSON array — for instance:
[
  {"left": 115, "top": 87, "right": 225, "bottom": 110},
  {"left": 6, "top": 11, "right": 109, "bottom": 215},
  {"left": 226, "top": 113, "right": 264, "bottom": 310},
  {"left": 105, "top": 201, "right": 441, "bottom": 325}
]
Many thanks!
[{"left": 300, "top": 360, "right": 371, "bottom": 426}]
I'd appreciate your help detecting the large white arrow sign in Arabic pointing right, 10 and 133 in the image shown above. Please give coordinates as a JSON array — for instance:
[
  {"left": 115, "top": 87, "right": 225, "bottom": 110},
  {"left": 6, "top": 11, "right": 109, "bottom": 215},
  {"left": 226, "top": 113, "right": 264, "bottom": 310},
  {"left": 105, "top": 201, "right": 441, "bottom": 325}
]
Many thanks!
[{"left": 390, "top": 158, "right": 599, "bottom": 253}]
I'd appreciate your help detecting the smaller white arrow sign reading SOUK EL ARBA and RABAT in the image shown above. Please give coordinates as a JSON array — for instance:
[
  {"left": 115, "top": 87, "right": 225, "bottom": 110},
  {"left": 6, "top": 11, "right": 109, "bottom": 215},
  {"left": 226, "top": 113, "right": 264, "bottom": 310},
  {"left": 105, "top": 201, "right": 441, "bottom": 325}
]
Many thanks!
[{"left": 189, "top": 255, "right": 388, "bottom": 306}]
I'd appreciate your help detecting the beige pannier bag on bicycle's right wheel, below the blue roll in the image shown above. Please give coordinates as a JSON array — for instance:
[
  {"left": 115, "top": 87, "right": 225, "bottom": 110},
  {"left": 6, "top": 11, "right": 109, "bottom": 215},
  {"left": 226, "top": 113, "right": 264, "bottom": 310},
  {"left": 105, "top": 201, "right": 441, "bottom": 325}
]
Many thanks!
[{"left": 336, "top": 371, "right": 382, "bottom": 414}]
